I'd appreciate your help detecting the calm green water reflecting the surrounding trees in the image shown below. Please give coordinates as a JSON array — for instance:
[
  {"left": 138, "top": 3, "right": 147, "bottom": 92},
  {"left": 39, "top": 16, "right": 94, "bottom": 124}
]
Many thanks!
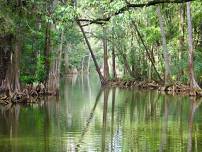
[{"left": 0, "top": 76, "right": 202, "bottom": 152}]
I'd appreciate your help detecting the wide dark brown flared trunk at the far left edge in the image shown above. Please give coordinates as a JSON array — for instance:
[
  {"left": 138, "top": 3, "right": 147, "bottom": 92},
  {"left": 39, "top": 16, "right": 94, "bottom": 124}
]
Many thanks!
[{"left": 0, "top": 35, "right": 21, "bottom": 93}]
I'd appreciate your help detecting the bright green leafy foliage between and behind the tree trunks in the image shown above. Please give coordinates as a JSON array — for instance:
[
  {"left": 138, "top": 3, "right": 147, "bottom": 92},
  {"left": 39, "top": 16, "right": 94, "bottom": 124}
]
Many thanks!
[{"left": 0, "top": 0, "right": 202, "bottom": 83}]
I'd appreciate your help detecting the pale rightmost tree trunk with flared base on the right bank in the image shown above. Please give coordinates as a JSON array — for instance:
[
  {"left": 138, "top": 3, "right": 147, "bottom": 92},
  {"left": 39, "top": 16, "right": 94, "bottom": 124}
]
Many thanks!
[{"left": 186, "top": 2, "right": 200, "bottom": 89}]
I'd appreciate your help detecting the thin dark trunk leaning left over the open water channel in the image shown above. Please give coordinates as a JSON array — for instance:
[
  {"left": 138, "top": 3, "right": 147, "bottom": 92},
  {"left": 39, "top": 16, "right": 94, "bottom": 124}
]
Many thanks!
[{"left": 77, "top": 21, "right": 107, "bottom": 85}]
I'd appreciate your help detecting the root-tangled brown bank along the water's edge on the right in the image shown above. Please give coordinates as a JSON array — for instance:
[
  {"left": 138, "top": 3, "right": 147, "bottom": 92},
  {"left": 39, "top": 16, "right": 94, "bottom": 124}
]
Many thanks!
[{"left": 107, "top": 79, "right": 202, "bottom": 97}]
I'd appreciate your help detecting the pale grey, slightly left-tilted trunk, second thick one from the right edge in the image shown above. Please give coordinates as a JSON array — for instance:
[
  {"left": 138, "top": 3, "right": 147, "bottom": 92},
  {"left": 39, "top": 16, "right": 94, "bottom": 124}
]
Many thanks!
[{"left": 157, "top": 6, "right": 171, "bottom": 85}]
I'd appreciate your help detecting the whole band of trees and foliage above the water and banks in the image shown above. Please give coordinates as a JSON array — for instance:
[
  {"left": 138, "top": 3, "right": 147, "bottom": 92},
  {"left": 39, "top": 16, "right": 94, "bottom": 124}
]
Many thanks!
[{"left": 0, "top": 0, "right": 202, "bottom": 92}]
